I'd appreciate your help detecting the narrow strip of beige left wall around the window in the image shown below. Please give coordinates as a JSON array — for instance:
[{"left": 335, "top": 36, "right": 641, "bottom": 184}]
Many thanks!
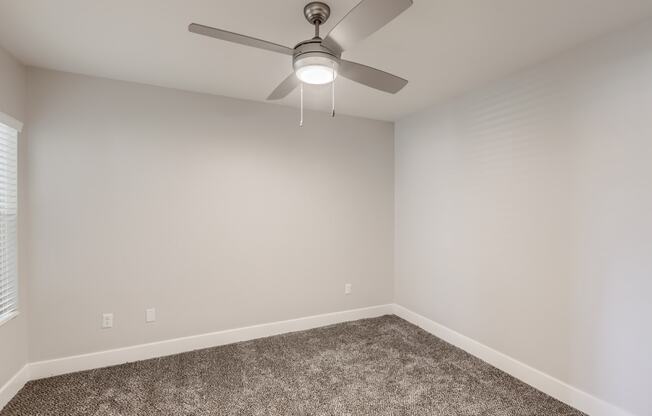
[{"left": 0, "top": 48, "right": 27, "bottom": 387}]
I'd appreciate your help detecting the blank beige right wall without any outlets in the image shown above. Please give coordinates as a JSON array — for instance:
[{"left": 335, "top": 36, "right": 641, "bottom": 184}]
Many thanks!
[{"left": 395, "top": 22, "right": 652, "bottom": 415}]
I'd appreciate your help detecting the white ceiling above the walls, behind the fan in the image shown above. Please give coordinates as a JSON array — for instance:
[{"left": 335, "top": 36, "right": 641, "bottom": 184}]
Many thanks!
[{"left": 0, "top": 0, "right": 652, "bottom": 120}]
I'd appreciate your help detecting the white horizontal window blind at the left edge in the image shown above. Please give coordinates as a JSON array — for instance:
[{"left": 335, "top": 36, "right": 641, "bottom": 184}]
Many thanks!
[{"left": 0, "top": 122, "right": 18, "bottom": 323}]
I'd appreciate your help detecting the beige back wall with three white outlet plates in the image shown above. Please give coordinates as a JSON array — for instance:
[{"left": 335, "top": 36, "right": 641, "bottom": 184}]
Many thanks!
[{"left": 28, "top": 69, "right": 394, "bottom": 361}]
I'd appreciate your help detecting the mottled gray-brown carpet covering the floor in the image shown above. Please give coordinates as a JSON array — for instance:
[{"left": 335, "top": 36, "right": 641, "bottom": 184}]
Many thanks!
[{"left": 0, "top": 316, "right": 582, "bottom": 416}]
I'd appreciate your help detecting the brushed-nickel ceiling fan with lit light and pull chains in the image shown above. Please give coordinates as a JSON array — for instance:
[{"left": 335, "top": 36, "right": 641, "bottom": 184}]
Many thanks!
[{"left": 188, "top": 0, "right": 412, "bottom": 104}]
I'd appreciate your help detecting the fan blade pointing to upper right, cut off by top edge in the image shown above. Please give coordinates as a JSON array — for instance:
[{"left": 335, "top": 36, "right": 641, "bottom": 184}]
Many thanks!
[{"left": 322, "top": 0, "right": 412, "bottom": 52}]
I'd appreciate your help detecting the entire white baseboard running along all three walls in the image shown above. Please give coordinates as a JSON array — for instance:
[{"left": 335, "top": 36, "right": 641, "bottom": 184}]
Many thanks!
[{"left": 0, "top": 304, "right": 635, "bottom": 416}]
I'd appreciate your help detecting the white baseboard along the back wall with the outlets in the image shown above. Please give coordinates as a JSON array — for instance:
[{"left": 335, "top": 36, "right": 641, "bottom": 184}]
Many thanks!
[{"left": 29, "top": 304, "right": 394, "bottom": 380}]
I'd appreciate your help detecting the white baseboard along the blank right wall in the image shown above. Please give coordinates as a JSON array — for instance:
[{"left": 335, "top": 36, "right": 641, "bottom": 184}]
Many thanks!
[{"left": 394, "top": 305, "right": 635, "bottom": 416}]
